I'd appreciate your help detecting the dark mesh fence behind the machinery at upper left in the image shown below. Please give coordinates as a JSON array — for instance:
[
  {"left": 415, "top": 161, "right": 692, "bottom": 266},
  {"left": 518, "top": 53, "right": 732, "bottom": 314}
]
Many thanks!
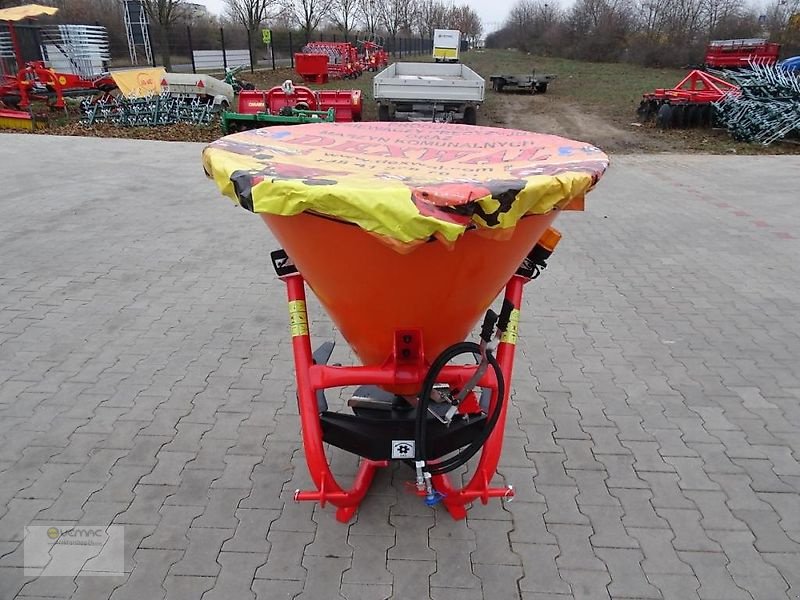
[{"left": 120, "top": 26, "right": 433, "bottom": 73}]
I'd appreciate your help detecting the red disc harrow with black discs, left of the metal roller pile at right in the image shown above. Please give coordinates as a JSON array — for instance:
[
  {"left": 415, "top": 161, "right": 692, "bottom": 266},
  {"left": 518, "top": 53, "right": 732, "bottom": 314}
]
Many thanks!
[{"left": 637, "top": 70, "right": 739, "bottom": 129}]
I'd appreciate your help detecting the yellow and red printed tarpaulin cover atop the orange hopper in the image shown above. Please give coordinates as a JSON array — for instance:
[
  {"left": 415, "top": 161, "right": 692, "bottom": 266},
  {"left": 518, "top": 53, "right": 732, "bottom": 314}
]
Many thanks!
[{"left": 203, "top": 123, "right": 608, "bottom": 250}]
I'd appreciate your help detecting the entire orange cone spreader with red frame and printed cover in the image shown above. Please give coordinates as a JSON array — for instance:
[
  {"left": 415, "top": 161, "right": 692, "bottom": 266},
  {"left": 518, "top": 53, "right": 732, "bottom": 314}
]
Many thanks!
[{"left": 203, "top": 123, "right": 608, "bottom": 522}]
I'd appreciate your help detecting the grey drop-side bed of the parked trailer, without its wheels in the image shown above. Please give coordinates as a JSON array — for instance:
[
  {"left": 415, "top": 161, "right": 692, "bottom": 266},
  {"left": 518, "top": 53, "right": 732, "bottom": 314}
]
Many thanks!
[{"left": 373, "top": 62, "right": 484, "bottom": 103}]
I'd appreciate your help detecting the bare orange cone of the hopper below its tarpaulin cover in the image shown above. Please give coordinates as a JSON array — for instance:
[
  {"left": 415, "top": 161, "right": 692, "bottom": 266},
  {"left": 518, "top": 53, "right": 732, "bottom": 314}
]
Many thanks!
[{"left": 262, "top": 211, "right": 556, "bottom": 365}]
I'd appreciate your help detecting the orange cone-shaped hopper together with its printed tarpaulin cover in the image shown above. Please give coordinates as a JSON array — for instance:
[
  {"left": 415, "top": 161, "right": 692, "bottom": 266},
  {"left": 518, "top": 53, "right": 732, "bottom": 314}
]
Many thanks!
[{"left": 204, "top": 123, "right": 607, "bottom": 378}]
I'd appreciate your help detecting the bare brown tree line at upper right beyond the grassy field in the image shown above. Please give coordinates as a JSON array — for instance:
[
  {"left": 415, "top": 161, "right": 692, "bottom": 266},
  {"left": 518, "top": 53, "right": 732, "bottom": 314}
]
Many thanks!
[{"left": 486, "top": 0, "right": 800, "bottom": 66}]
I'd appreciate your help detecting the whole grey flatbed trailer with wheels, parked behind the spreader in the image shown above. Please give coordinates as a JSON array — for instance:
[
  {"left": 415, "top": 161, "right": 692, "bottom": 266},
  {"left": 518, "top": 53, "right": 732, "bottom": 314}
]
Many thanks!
[{"left": 373, "top": 62, "right": 485, "bottom": 125}]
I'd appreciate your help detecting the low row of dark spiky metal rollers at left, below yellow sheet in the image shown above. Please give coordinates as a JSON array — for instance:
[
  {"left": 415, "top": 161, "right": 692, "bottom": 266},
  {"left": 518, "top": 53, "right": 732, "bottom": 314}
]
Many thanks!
[{"left": 81, "top": 94, "right": 215, "bottom": 127}]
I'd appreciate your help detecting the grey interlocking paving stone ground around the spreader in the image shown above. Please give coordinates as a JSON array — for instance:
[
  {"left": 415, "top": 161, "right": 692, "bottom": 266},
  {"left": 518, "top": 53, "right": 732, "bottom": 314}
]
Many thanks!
[{"left": 0, "top": 135, "right": 800, "bottom": 600}]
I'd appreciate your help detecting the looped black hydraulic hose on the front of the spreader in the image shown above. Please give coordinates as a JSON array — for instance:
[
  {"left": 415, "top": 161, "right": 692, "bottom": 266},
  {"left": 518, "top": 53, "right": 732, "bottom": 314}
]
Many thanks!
[{"left": 414, "top": 342, "right": 505, "bottom": 475}]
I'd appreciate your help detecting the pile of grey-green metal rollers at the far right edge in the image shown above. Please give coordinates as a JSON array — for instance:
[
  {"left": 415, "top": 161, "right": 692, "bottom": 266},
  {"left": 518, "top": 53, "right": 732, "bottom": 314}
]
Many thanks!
[{"left": 714, "top": 63, "right": 800, "bottom": 146}]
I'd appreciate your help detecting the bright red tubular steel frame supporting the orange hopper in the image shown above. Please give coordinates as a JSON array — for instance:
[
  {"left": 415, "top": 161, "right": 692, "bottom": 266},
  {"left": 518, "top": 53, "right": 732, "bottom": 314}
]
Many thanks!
[{"left": 283, "top": 273, "right": 530, "bottom": 523}]
